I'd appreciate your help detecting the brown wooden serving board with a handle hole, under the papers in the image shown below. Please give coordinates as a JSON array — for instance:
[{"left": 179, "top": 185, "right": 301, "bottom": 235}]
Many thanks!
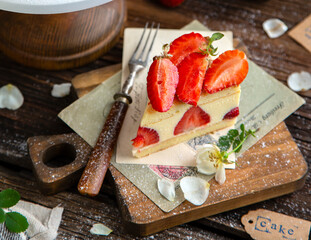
[{"left": 28, "top": 123, "right": 308, "bottom": 236}]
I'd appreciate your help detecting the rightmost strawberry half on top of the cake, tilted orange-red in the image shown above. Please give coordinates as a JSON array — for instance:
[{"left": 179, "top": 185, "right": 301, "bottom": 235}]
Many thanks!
[{"left": 203, "top": 50, "right": 248, "bottom": 93}]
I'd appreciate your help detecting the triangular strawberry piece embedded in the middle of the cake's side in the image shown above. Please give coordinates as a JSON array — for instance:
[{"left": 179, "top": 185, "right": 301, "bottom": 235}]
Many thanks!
[{"left": 174, "top": 106, "right": 210, "bottom": 135}]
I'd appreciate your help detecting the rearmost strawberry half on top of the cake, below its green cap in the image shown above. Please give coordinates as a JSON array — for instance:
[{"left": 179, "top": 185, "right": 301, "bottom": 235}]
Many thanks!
[{"left": 168, "top": 32, "right": 207, "bottom": 66}]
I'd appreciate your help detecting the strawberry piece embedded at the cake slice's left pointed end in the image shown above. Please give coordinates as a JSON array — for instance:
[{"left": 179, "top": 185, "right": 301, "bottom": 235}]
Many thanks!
[{"left": 132, "top": 126, "right": 159, "bottom": 148}]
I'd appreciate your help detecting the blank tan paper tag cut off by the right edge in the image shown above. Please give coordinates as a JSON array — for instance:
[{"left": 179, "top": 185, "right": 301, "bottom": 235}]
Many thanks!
[{"left": 288, "top": 14, "right": 311, "bottom": 52}]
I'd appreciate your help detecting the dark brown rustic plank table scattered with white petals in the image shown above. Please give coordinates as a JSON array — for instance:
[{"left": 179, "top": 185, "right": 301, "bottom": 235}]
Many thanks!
[{"left": 0, "top": 0, "right": 311, "bottom": 239}]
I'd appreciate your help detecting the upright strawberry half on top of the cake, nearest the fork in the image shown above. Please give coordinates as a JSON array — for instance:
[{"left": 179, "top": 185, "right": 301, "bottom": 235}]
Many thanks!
[{"left": 147, "top": 57, "right": 179, "bottom": 112}]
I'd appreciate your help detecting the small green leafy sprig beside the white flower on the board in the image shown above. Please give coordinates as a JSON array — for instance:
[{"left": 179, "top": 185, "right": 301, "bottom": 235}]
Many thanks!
[{"left": 217, "top": 124, "right": 256, "bottom": 164}]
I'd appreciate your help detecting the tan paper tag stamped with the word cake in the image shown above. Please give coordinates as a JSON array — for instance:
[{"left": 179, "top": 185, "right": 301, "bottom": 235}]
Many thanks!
[{"left": 242, "top": 209, "right": 311, "bottom": 240}]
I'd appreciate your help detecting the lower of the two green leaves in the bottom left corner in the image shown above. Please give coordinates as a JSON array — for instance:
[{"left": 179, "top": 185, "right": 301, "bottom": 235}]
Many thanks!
[{"left": 5, "top": 212, "right": 29, "bottom": 233}]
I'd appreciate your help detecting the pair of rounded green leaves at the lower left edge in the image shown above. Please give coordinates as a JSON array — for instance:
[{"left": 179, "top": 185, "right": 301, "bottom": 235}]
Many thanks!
[{"left": 0, "top": 188, "right": 29, "bottom": 233}]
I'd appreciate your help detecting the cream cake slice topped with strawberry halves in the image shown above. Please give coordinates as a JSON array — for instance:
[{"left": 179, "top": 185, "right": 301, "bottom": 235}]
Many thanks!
[{"left": 132, "top": 33, "right": 248, "bottom": 157}]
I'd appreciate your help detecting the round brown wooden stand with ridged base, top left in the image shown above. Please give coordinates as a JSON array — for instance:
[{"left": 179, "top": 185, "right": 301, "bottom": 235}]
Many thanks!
[{"left": 0, "top": 0, "right": 126, "bottom": 70}]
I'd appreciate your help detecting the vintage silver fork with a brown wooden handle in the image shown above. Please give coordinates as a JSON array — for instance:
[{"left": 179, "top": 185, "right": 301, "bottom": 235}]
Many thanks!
[{"left": 78, "top": 23, "right": 160, "bottom": 196}]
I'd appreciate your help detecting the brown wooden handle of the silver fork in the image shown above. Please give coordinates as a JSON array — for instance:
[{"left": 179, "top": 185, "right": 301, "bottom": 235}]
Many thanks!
[{"left": 78, "top": 98, "right": 128, "bottom": 197}]
